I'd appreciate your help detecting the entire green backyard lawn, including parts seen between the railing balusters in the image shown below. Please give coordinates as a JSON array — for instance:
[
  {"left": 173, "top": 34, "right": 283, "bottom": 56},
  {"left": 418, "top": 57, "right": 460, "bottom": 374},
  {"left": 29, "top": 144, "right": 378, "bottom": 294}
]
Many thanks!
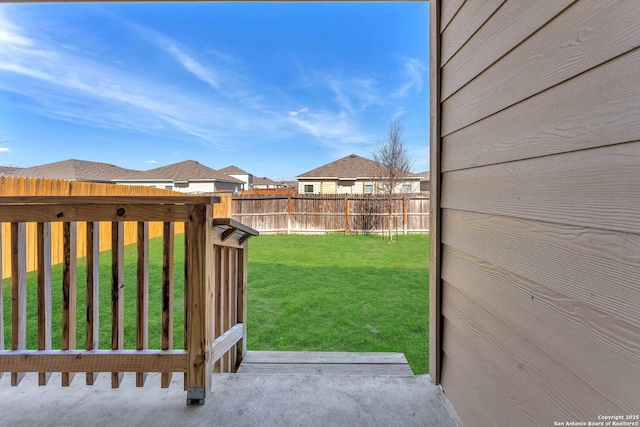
[{"left": 3, "top": 234, "right": 429, "bottom": 374}]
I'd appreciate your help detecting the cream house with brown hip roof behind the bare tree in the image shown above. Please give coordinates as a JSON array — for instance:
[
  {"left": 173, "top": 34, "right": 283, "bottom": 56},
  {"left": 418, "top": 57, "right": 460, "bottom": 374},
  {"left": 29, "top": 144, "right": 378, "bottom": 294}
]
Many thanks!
[{"left": 296, "top": 154, "right": 421, "bottom": 194}]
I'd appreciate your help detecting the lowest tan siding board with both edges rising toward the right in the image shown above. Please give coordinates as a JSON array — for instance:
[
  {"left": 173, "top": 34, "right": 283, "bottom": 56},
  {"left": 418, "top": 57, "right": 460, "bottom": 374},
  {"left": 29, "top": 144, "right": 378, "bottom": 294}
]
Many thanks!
[{"left": 442, "top": 50, "right": 640, "bottom": 171}]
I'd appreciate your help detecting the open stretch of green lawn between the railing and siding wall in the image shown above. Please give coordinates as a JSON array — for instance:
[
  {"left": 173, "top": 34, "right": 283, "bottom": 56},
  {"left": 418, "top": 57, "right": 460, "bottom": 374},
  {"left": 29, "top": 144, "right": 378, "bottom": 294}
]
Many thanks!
[{"left": 247, "top": 234, "right": 429, "bottom": 374}]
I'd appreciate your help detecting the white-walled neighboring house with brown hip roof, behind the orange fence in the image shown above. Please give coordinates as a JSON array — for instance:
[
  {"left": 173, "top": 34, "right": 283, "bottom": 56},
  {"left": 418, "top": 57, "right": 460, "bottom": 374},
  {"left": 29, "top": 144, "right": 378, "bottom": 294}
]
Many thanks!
[{"left": 113, "top": 160, "right": 244, "bottom": 193}]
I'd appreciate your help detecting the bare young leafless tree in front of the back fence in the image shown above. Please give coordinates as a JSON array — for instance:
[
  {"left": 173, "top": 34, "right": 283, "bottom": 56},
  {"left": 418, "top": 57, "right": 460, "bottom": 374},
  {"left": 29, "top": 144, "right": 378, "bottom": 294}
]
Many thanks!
[{"left": 371, "top": 120, "right": 413, "bottom": 242}]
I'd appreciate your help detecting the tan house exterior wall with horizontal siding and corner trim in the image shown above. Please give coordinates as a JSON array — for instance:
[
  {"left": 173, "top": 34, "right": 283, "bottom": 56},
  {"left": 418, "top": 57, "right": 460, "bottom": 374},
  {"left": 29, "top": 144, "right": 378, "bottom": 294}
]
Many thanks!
[{"left": 430, "top": 0, "right": 640, "bottom": 426}]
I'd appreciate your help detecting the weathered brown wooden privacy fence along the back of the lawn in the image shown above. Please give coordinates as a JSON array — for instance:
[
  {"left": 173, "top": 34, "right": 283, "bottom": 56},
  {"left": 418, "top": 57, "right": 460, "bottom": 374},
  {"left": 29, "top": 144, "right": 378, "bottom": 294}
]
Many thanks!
[{"left": 233, "top": 193, "right": 429, "bottom": 234}]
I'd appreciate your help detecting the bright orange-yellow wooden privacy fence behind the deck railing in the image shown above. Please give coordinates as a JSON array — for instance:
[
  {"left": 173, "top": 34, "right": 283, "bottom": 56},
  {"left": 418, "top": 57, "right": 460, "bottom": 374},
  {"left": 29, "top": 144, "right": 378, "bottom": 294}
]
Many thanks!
[{"left": 0, "top": 176, "right": 231, "bottom": 279}]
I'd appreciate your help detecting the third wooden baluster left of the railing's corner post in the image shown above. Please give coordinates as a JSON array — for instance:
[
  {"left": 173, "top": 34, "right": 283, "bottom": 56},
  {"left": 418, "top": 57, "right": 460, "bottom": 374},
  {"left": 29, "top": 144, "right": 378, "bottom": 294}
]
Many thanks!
[{"left": 111, "top": 222, "right": 124, "bottom": 388}]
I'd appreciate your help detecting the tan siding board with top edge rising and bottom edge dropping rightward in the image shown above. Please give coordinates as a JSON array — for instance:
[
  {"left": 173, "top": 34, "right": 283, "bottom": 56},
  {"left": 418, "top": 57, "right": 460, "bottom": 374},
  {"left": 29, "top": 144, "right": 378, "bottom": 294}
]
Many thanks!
[{"left": 441, "top": 142, "right": 640, "bottom": 233}]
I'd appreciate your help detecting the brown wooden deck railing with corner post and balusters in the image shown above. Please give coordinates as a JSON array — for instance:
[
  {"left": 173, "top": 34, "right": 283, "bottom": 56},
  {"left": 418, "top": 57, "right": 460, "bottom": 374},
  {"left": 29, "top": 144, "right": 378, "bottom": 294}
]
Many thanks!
[{"left": 0, "top": 196, "right": 258, "bottom": 404}]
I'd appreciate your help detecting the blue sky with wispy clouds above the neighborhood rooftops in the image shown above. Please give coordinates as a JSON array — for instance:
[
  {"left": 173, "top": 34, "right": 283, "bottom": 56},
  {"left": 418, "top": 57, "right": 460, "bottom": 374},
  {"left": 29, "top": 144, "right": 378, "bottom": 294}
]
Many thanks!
[{"left": 0, "top": 2, "right": 429, "bottom": 180}]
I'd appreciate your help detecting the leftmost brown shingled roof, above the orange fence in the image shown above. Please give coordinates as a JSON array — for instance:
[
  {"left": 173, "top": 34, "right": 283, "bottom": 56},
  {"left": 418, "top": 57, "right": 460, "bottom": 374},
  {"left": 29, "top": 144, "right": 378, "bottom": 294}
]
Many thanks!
[{"left": 7, "top": 159, "right": 139, "bottom": 182}]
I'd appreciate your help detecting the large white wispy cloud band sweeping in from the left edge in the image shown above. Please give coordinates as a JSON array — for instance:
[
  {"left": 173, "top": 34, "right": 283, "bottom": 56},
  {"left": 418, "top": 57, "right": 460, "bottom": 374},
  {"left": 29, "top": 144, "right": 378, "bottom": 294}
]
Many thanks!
[{"left": 0, "top": 9, "right": 286, "bottom": 149}]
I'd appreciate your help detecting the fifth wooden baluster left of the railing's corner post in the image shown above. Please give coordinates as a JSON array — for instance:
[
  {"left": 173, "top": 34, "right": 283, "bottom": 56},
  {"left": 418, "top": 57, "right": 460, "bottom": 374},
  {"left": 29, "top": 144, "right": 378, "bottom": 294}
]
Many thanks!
[{"left": 62, "top": 222, "right": 77, "bottom": 387}]
